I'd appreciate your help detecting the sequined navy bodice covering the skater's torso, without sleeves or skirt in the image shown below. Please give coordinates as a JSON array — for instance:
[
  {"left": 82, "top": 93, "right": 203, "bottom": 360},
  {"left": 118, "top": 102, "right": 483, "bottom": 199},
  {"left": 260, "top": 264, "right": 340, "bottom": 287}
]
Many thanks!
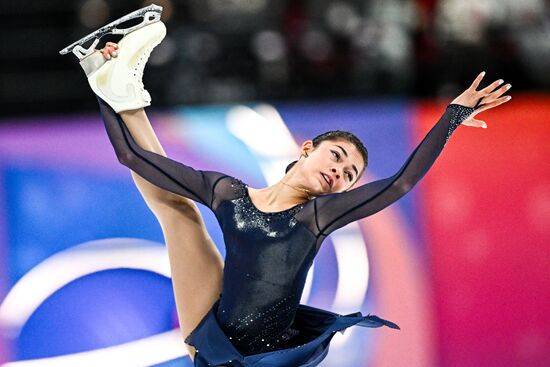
[{"left": 218, "top": 178, "right": 315, "bottom": 355}]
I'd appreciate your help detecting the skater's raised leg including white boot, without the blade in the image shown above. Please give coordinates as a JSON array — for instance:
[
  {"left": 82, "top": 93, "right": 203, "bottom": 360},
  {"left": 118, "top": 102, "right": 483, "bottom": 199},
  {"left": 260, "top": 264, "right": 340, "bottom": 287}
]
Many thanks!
[{"left": 65, "top": 12, "right": 223, "bottom": 358}]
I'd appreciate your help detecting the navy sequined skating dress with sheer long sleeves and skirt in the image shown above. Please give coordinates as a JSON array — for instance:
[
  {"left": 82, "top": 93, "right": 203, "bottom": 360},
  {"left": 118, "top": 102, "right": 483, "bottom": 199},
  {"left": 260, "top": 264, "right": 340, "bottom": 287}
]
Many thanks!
[{"left": 99, "top": 100, "right": 474, "bottom": 367}]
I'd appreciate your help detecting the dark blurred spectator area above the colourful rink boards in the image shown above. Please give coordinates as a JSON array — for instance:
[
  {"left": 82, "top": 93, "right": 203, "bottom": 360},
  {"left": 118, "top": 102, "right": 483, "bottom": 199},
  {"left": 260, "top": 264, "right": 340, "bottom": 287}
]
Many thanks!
[{"left": 0, "top": 0, "right": 550, "bottom": 117}]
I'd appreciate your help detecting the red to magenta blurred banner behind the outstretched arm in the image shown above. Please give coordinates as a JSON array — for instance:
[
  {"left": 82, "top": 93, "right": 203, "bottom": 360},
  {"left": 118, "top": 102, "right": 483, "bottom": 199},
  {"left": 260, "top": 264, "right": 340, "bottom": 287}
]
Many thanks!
[{"left": 415, "top": 96, "right": 550, "bottom": 367}]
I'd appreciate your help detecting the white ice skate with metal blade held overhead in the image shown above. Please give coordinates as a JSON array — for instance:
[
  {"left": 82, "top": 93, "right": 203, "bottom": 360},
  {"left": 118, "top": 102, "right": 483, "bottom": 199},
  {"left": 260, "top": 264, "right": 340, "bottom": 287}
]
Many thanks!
[{"left": 60, "top": 5, "right": 166, "bottom": 113}]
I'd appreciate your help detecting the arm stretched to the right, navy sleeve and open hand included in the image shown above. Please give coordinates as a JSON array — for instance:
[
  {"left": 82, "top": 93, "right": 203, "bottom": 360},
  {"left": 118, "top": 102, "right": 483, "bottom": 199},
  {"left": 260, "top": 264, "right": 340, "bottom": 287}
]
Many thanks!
[{"left": 315, "top": 73, "right": 511, "bottom": 235}]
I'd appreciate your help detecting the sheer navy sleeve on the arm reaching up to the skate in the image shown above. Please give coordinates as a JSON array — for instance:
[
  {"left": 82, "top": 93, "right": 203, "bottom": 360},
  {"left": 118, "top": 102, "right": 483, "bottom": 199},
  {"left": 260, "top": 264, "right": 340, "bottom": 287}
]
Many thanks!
[{"left": 98, "top": 98, "right": 227, "bottom": 208}]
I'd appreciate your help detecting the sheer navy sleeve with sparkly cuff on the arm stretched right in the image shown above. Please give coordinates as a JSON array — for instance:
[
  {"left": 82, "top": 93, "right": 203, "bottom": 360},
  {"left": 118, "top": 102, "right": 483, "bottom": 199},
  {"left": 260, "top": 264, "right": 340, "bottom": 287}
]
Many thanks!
[{"left": 310, "top": 104, "right": 474, "bottom": 235}]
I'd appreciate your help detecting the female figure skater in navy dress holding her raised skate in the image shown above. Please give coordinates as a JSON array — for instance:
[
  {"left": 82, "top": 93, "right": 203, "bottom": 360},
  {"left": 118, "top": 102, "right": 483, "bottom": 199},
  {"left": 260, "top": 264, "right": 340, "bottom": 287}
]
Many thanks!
[{"left": 64, "top": 6, "right": 511, "bottom": 367}]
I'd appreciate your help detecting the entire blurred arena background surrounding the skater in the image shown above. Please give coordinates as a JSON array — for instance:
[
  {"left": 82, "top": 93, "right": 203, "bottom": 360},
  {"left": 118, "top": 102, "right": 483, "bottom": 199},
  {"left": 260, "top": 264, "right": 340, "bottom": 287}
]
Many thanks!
[{"left": 0, "top": 0, "right": 550, "bottom": 367}]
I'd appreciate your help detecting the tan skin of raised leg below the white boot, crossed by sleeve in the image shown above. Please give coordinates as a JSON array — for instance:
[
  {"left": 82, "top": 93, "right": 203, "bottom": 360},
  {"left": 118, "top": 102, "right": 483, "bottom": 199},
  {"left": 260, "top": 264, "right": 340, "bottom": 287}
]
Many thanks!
[{"left": 120, "top": 109, "right": 223, "bottom": 358}]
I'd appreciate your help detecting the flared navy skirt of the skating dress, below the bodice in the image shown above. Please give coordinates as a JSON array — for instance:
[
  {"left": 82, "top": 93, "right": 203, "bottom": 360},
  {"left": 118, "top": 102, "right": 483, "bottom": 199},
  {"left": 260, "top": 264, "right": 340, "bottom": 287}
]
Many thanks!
[{"left": 185, "top": 299, "right": 399, "bottom": 367}]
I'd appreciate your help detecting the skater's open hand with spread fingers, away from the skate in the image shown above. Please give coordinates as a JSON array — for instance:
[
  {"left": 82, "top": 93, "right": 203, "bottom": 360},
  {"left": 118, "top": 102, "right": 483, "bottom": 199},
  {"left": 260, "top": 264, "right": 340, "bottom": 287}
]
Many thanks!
[{"left": 451, "top": 72, "right": 512, "bottom": 129}]
